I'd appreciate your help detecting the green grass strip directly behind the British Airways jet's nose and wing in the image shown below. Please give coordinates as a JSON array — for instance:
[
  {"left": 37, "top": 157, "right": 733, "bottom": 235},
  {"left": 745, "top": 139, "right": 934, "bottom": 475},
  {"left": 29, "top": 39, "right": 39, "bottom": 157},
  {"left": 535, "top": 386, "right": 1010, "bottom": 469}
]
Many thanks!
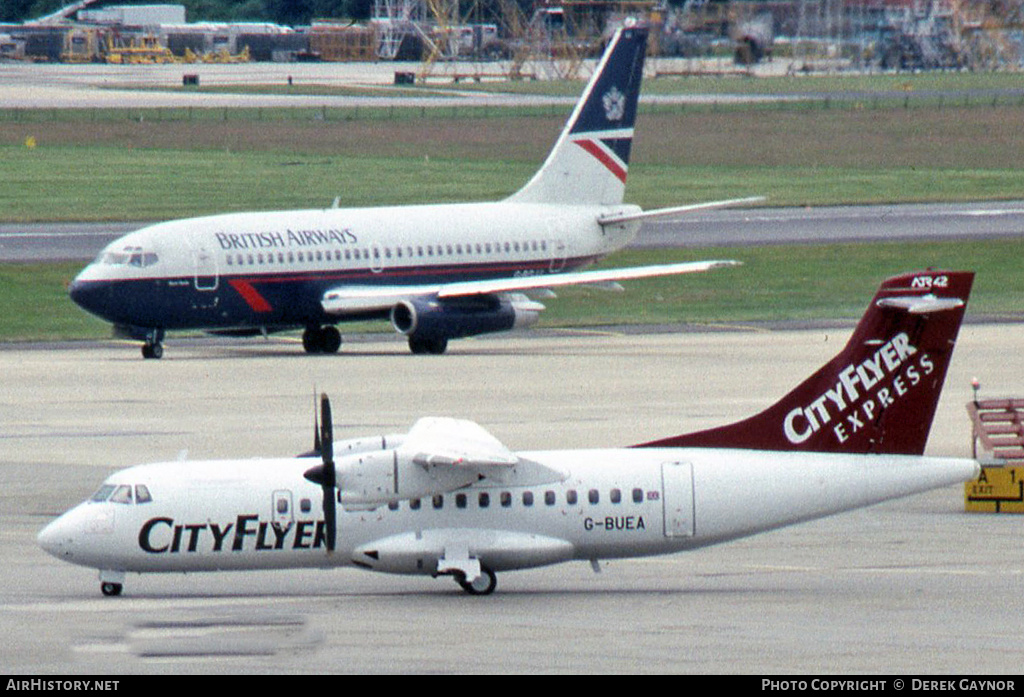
[{"left": 0, "top": 238, "right": 1024, "bottom": 342}]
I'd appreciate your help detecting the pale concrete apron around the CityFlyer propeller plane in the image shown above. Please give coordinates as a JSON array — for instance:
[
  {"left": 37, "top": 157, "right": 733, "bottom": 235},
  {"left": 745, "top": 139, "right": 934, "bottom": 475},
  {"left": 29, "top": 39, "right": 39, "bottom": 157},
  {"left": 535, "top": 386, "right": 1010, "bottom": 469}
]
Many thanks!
[{"left": 0, "top": 324, "right": 1024, "bottom": 676}]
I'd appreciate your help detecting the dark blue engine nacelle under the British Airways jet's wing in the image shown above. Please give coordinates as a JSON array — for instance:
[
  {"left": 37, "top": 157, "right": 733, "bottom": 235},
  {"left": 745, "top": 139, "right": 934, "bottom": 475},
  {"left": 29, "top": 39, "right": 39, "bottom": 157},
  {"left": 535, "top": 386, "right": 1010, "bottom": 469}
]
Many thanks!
[{"left": 391, "top": 294, "right": 544, "bottom": 339}]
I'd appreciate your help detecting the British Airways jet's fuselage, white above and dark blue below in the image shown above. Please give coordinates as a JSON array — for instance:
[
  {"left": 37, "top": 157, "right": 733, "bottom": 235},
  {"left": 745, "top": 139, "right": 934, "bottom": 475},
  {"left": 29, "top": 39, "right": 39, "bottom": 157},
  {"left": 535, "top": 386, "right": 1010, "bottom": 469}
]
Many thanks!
[{"left": 71, "top": 202, "right": 639, "bottom": 330}]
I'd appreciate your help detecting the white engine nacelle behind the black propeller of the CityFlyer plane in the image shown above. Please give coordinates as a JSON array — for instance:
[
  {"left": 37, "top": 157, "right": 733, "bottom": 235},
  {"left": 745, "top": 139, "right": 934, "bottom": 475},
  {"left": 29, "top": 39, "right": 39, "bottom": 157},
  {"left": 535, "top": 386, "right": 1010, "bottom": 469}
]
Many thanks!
[{"left": 337, "top": 449, "right": 478, "bottom": 510}]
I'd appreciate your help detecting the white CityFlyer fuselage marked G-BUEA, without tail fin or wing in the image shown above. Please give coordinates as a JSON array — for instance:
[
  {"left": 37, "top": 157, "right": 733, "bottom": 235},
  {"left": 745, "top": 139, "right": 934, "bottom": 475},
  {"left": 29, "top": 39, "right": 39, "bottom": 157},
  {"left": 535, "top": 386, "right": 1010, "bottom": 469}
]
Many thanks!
[{"left": 40, "top": 448, "right": 977, "bottom": 575}]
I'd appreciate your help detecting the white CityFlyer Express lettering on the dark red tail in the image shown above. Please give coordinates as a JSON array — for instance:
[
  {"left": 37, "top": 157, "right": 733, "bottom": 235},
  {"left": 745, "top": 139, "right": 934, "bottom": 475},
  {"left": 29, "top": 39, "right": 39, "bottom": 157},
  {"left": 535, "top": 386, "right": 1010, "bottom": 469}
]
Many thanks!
[{"left": 782, "top": 332, "right": 935, "bottom": 445}]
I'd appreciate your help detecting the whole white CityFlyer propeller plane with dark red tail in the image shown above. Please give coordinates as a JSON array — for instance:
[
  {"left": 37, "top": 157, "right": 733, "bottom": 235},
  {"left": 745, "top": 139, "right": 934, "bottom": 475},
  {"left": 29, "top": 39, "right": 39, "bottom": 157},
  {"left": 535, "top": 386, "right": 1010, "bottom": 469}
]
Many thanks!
[{"left": 39, "top": 271, "right": 978, "bottom": 595}]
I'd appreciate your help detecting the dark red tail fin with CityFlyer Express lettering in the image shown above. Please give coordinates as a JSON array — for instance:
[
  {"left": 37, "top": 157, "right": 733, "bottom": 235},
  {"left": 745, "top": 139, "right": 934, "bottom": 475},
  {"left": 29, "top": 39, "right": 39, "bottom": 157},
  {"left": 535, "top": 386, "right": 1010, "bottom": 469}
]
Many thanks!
[{"left": 638, "top": 271, "right": 974, "bottom": 454}]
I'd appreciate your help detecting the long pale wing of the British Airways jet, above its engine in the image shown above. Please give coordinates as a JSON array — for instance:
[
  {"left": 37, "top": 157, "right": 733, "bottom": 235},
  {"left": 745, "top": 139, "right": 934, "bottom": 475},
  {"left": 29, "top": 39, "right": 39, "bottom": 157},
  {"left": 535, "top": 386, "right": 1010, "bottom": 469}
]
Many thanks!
[{"left": 321, "top": 261, "right": 740, "bottom": 314}]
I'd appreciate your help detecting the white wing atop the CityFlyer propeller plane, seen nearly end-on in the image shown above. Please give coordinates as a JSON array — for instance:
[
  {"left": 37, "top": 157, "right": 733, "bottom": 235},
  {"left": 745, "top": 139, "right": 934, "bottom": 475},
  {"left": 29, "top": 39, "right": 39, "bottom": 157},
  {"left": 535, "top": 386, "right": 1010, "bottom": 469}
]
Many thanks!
[{"left": 398, "top": 417, "right": 519, "bottom": 470}]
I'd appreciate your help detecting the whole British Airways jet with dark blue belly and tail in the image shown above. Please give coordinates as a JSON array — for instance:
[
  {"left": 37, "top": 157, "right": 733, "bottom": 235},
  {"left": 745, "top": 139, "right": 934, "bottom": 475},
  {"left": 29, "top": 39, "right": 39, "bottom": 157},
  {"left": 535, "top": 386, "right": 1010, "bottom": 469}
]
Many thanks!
[{"left": 64, "top": 22, "right": 753, "bottom": 358}]
